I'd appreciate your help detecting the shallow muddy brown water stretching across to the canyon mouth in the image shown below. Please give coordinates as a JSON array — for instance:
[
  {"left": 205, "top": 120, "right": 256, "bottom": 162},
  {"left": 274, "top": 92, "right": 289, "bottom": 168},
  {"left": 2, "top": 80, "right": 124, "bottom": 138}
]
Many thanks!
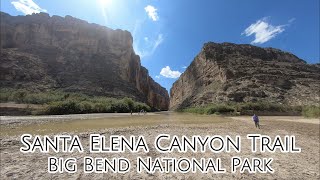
[{"left": 0, "top": 112, "right": 230, "bottom": 136}]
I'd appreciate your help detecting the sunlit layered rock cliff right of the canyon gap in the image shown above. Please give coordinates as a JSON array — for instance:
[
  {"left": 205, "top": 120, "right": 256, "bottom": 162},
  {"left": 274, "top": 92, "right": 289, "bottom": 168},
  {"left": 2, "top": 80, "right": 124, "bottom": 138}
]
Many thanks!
[{"left": 170, "top": 42, "right": 320, "bottom": 109}]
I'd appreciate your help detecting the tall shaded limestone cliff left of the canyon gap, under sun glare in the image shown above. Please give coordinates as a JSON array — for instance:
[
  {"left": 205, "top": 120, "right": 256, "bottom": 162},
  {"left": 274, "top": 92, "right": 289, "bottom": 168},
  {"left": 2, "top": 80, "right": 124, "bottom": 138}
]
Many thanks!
[{"left": 0, "top": 12, "right": 169, "bottom": 110}]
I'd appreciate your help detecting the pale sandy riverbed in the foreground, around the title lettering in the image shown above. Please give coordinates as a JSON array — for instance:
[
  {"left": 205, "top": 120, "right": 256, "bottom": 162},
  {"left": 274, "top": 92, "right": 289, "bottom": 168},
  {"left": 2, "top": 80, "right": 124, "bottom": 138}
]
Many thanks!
[{"left": 0, "top": 113, "right": 320, "bottom": 179}]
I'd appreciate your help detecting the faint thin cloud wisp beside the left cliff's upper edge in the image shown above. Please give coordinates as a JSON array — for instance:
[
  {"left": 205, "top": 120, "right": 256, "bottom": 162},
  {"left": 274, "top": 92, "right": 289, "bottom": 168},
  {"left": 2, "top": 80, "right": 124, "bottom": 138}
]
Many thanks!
[{"left": 133, "top": 34, "right": 164, "bottom": 58}]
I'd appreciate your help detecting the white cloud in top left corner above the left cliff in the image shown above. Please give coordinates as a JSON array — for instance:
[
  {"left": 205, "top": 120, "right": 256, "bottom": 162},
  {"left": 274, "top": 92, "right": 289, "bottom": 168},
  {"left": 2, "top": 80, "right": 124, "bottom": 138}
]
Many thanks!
[{"left": 11, "top": 0, "right": 47, "bottom": 14}]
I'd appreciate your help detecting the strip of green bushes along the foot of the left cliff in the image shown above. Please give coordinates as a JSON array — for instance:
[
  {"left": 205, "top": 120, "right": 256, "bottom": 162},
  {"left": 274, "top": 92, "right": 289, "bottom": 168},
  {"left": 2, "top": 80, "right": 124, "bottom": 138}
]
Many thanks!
[{"left": 0, "top": 89, "right": 151, "bottom": 114}]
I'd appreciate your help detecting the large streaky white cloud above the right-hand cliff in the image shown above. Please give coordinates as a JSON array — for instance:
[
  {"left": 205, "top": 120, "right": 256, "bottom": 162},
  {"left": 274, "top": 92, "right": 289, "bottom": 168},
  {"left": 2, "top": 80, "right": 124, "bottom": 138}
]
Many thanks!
[{"left": 241, "top": 18, "right": 286, "bottom": 44}]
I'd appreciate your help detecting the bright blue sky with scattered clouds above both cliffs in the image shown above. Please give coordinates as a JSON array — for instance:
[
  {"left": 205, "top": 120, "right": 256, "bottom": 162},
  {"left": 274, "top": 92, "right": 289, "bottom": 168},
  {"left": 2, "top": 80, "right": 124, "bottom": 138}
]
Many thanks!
[{"left": 1, "top": 0, "right": 320, "bottom": 90}]
